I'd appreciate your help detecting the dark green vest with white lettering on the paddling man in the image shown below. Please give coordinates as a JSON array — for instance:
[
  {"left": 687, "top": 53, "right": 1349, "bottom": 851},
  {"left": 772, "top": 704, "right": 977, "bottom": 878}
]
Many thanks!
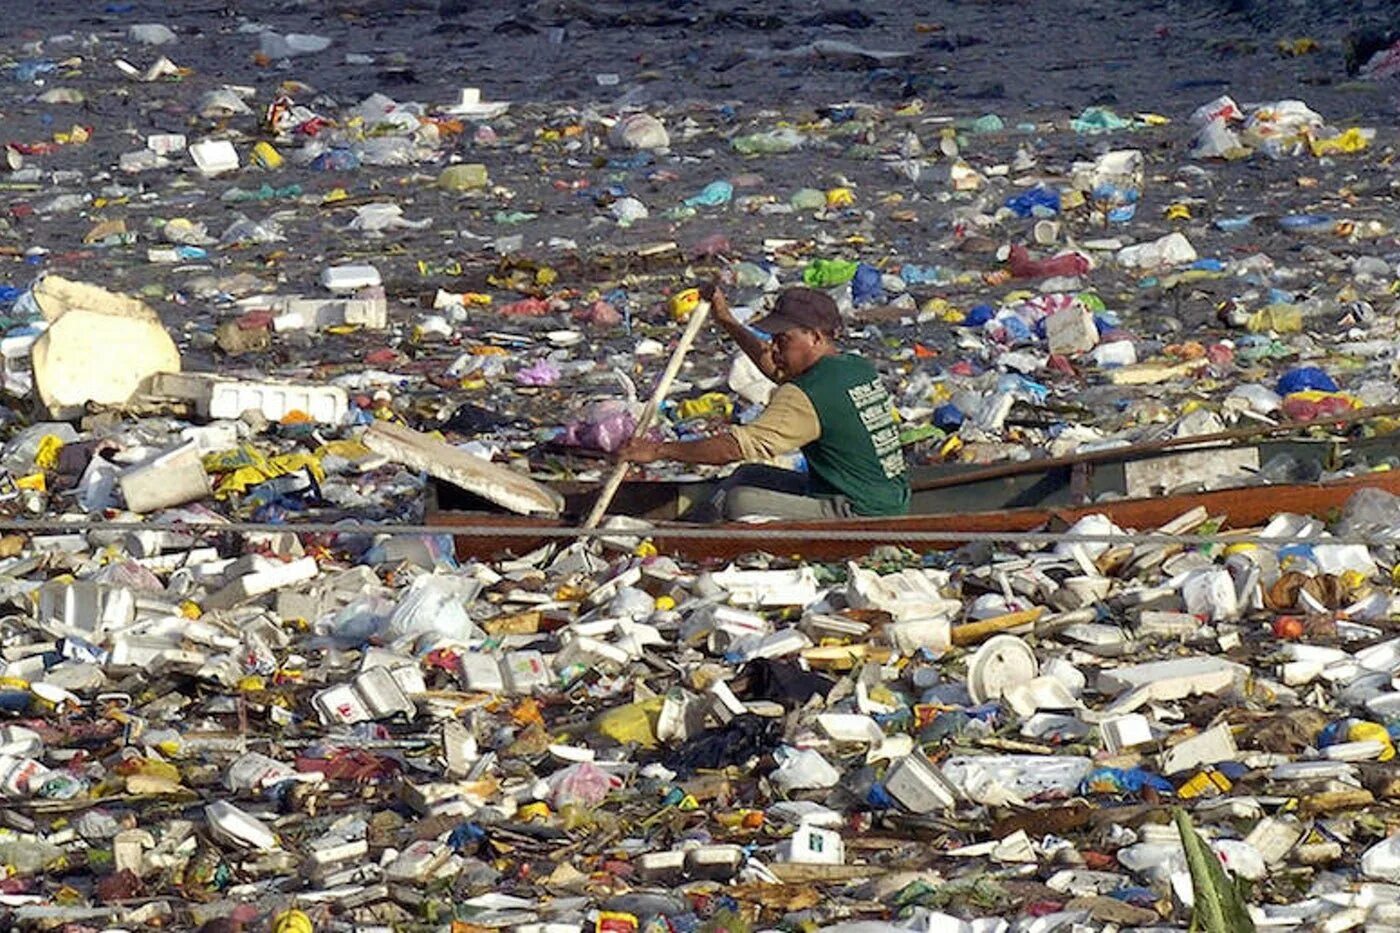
[{"left": 792, "top": 353, "right": 909, "bottom": 516}]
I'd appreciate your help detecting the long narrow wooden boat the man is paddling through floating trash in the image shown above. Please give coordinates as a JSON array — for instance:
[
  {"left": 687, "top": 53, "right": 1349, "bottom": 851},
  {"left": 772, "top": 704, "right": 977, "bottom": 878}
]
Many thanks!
[{"left": 426, "top": 406, "right": 1400, "bottom": 559}]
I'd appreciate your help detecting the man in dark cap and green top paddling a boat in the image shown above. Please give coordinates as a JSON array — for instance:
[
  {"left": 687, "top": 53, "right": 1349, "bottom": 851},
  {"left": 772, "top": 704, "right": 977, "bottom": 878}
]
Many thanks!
[{"left": 619, "top": 287, "right": 909, "bottom": 520}]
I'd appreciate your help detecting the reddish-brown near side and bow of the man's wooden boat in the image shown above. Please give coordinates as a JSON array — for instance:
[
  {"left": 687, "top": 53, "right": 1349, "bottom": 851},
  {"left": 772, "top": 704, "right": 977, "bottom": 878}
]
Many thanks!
[{"left": 427, "top": 445, "right": 1400, "bottom": 560}]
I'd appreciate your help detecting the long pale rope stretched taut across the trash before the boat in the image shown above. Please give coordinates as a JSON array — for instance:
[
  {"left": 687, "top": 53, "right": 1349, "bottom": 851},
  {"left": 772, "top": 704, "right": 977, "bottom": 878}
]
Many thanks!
[{"left": 8, "top": 518, "right": 1400, "bottom": 548}]
